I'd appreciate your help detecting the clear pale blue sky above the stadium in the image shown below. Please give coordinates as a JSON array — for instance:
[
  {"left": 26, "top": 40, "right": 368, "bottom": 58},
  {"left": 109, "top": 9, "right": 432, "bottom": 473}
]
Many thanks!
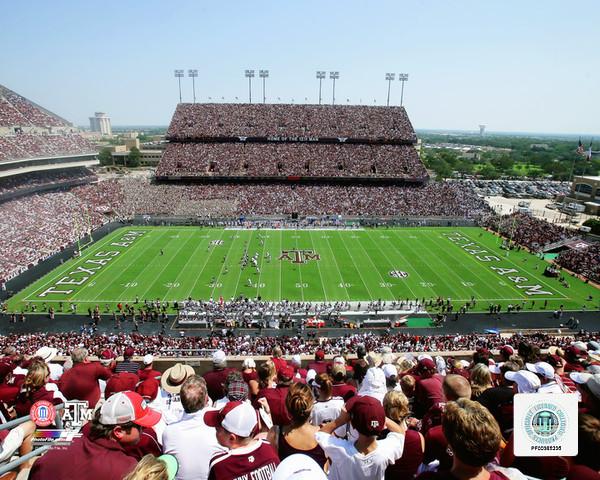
[{"left": 0, "top": 0, "right": 600, "bottom": 134}]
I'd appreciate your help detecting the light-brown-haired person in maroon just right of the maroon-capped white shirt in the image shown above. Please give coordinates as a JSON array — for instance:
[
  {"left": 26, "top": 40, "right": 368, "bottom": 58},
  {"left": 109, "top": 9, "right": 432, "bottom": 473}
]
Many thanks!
[{"left": 379, "top": 390, "right": 425, "bottom": 480}]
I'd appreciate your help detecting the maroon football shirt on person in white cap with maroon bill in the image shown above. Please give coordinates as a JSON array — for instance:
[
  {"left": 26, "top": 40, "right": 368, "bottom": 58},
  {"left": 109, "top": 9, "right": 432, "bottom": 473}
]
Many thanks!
[{"left": 208, "top": 440, "right": 279, "bottom": 480}]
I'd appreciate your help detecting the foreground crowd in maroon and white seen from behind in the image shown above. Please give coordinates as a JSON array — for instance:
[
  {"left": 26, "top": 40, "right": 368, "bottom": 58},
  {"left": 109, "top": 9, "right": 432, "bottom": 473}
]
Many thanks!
[{"left": 0, "top": 334, "right": 600, "bottom": 480}]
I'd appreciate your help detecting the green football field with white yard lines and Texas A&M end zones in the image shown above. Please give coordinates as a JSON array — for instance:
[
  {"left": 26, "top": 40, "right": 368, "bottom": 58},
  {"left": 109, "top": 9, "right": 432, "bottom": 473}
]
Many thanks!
[{"left": 8, "top": 227, "right": 600, "bottom": 313}]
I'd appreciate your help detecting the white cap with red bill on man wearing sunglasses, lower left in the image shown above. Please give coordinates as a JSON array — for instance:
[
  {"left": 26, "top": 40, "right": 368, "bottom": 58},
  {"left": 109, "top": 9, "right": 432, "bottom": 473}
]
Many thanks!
[{"left": 100, "top": 392, "right": 161, "bottom": 427}]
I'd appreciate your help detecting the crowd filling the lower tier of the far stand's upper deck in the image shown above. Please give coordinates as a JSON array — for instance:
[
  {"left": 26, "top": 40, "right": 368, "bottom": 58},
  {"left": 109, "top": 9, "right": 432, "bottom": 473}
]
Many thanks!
[{"left": 156, "top": 143, "right": 427, "bottom": 179}]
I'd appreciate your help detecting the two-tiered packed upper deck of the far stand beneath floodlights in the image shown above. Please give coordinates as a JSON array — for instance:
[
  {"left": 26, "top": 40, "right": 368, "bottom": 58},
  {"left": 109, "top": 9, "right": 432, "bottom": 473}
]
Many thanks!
[{"left": 156, "top": 104, "right": 427, "bottom": 183}]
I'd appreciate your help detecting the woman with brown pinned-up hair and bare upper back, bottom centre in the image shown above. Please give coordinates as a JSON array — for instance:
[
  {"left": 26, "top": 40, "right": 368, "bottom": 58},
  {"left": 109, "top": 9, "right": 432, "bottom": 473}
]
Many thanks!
[{"left": 278, "top": 383, "right": 327, "bottom": 468}]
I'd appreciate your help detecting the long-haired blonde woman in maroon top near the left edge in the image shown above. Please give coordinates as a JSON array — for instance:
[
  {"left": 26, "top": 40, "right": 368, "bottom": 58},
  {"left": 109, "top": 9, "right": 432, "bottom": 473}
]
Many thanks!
[{"left": 15, "top": 358, "right": 67, "bottom": 417}]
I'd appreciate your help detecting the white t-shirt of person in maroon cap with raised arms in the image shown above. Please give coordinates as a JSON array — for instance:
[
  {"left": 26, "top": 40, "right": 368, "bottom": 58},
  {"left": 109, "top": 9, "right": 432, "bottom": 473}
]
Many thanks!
[{"left": 315, "top": 432, "right": 404, "bottom": 480}]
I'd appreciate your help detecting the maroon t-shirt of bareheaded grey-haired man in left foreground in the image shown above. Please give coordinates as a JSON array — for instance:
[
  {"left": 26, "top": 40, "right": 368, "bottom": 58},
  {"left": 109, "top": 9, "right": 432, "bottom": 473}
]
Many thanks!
[{"left": 58, "top": 362, "right": 112, "bottom": 408}]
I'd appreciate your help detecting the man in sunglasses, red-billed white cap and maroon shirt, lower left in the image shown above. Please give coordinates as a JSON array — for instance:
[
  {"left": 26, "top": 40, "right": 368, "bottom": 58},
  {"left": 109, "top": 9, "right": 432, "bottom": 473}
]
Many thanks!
[{"left": 29, "top": 392, "right": 160, "bottom": 480}]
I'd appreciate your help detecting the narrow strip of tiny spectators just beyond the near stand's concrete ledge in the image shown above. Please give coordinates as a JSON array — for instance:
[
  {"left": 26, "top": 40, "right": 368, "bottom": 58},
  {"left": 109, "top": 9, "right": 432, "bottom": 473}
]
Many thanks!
[{"left": 0, "top": 332, "right": 600, "bottom": 357}]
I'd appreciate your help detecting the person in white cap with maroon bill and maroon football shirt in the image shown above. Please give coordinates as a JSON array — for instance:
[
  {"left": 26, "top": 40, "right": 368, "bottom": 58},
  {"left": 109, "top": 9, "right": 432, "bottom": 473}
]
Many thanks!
[{"left": 204, "top": 402, "right": 279, "bottom": 480}]
